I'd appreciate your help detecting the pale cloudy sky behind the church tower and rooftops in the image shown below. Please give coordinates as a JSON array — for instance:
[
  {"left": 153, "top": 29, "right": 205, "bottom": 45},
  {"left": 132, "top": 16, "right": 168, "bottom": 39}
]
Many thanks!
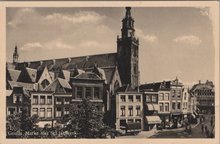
[{"left": 6, "top": 7, "right": 214, "bottom": 83}]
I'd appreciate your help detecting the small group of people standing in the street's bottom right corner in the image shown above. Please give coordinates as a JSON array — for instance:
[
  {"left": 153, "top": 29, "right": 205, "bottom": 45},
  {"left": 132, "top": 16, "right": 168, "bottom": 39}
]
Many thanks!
[{"left": 200, "top": 115, "right": 214, "bottom": 138}]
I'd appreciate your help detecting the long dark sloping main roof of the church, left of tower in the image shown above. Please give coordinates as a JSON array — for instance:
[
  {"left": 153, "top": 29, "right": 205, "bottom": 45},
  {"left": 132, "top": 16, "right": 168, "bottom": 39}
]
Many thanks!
[{"left": 16, "top": 53, "right": 117, "bottom": 71}]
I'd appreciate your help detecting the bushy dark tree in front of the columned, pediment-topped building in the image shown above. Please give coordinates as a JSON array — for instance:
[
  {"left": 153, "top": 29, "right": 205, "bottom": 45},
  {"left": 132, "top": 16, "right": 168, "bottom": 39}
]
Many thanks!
[{"left": 70, "top": 99, "right": 105, "bottom": 138}]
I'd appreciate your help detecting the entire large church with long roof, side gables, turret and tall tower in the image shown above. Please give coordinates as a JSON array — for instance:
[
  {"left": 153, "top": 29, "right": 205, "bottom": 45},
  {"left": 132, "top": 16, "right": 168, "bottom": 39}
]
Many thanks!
[{"left": 6, "top": 7, "right": 139, "bottom": 116}]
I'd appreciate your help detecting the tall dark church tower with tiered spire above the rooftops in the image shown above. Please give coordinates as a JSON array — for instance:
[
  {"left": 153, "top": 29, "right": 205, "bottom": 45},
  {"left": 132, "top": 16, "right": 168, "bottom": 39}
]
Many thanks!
[{"left": 117, "top": 7, "right": 139, "bottom": 88}]
